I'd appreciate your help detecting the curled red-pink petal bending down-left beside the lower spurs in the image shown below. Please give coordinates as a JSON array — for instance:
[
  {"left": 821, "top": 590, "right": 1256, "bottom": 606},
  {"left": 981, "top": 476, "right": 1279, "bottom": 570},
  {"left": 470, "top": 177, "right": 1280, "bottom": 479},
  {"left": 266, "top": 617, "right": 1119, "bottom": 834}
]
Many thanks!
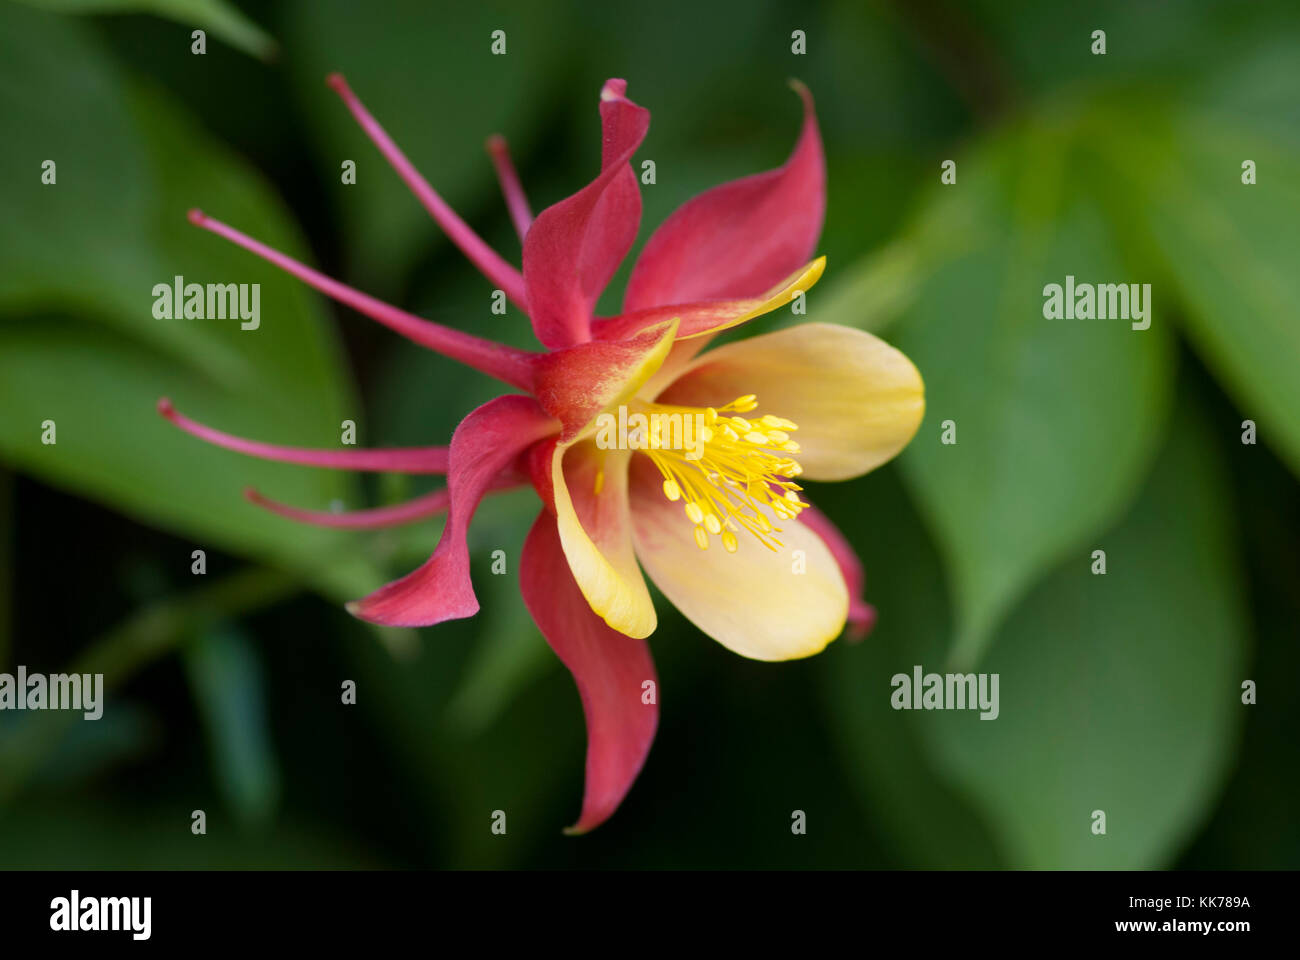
[{"left": 347, "top": 394, "right": 559, "bottom": 627}]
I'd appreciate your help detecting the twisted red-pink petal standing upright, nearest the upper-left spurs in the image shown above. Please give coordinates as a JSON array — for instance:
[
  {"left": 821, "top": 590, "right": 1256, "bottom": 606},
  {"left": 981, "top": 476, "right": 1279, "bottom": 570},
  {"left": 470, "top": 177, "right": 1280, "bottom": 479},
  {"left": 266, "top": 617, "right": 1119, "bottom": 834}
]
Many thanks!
[{"left": 524, "top": 79, "right": 650, "bottom": 350}]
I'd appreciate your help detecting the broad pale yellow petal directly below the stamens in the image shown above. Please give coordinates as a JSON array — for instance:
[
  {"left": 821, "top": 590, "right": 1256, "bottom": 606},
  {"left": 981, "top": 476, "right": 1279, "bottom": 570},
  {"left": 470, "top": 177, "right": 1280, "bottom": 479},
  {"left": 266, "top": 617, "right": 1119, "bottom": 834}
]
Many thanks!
[{"left": 631, "top": 455, "right": 849, "bottom": 661}]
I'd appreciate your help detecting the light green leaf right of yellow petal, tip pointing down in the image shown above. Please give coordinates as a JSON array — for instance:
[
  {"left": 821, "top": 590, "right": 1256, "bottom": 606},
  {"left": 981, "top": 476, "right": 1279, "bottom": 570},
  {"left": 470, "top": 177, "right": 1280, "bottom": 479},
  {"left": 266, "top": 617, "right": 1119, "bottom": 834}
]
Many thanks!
[{"left": 894, "top": 117, "right": 1170, "bottom": 665}]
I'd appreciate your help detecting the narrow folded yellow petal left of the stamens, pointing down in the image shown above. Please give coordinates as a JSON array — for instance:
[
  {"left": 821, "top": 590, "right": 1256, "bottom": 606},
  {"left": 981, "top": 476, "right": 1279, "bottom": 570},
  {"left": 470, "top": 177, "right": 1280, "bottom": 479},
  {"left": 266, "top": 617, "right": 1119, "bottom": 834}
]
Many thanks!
[{"left": 551, "top": 441, "right": 657, "bottom": 637}]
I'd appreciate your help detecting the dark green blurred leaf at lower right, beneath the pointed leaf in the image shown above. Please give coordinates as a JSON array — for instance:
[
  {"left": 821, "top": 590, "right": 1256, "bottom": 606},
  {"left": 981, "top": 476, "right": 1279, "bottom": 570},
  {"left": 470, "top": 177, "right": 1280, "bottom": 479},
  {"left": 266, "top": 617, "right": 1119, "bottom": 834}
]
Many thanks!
[{"left": 920, "top": 403, "right": 1253, "bottom": 869}]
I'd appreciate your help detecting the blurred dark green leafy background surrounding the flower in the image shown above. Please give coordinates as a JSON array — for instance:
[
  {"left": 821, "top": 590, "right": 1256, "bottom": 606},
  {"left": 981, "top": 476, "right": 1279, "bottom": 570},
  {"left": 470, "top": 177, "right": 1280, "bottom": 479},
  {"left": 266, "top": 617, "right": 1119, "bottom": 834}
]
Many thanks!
[{"left": 0, "top": 0, "right": 1300, "bottom": 868}]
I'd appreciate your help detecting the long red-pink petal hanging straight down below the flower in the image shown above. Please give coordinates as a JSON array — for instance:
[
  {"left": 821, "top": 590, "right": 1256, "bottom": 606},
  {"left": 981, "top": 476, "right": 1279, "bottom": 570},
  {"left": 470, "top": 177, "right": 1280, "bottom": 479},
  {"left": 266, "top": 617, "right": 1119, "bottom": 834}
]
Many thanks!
[{"left": 519, "top": 510, "right": 659, "bottom": 834}]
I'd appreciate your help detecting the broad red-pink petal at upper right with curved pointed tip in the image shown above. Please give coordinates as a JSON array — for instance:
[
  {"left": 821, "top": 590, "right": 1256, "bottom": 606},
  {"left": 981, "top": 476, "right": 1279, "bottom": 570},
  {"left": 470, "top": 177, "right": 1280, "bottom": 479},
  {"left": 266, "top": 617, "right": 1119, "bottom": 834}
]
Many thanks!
[{"left": 623, "top": 83, "right": 826, "bottom": 311}]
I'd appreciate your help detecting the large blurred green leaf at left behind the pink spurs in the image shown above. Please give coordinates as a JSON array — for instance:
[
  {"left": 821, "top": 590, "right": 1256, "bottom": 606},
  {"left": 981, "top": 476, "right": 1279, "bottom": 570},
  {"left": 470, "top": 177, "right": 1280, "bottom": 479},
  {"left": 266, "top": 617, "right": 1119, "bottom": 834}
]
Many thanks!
[{"left": 0, "top": 7, "right": 378, "bottom": 596}]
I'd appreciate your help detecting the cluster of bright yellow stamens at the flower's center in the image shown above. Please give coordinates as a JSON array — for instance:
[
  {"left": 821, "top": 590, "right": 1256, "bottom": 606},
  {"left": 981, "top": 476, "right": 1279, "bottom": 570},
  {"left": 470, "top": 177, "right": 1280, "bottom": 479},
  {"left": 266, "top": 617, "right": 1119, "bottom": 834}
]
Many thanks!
[{"left": 638, "top": 394, "right": 807, "bottom": 553}]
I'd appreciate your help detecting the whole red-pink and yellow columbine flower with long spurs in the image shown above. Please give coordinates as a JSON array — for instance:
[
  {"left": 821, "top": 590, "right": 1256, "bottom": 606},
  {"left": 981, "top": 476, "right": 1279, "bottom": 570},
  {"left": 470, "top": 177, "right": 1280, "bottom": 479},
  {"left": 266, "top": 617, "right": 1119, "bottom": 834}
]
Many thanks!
[{"left": 159, "top": 74, "right": 924, "bottom": 833}]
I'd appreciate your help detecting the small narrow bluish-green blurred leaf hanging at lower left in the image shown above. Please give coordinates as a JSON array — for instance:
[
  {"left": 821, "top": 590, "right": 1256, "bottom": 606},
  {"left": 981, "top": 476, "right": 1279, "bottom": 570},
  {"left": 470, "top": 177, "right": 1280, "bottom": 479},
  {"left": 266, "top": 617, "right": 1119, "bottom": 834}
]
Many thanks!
[{"left": 183, "top": 624, "right": 280, "bottom": 826}]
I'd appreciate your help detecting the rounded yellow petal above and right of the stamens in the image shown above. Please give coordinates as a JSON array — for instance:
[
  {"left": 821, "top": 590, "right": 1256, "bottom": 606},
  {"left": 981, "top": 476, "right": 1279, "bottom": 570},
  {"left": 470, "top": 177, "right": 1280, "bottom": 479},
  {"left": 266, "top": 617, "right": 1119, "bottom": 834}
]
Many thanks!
[{"left": 659, "top": 323, "right": 926, "bottom": 480}]
